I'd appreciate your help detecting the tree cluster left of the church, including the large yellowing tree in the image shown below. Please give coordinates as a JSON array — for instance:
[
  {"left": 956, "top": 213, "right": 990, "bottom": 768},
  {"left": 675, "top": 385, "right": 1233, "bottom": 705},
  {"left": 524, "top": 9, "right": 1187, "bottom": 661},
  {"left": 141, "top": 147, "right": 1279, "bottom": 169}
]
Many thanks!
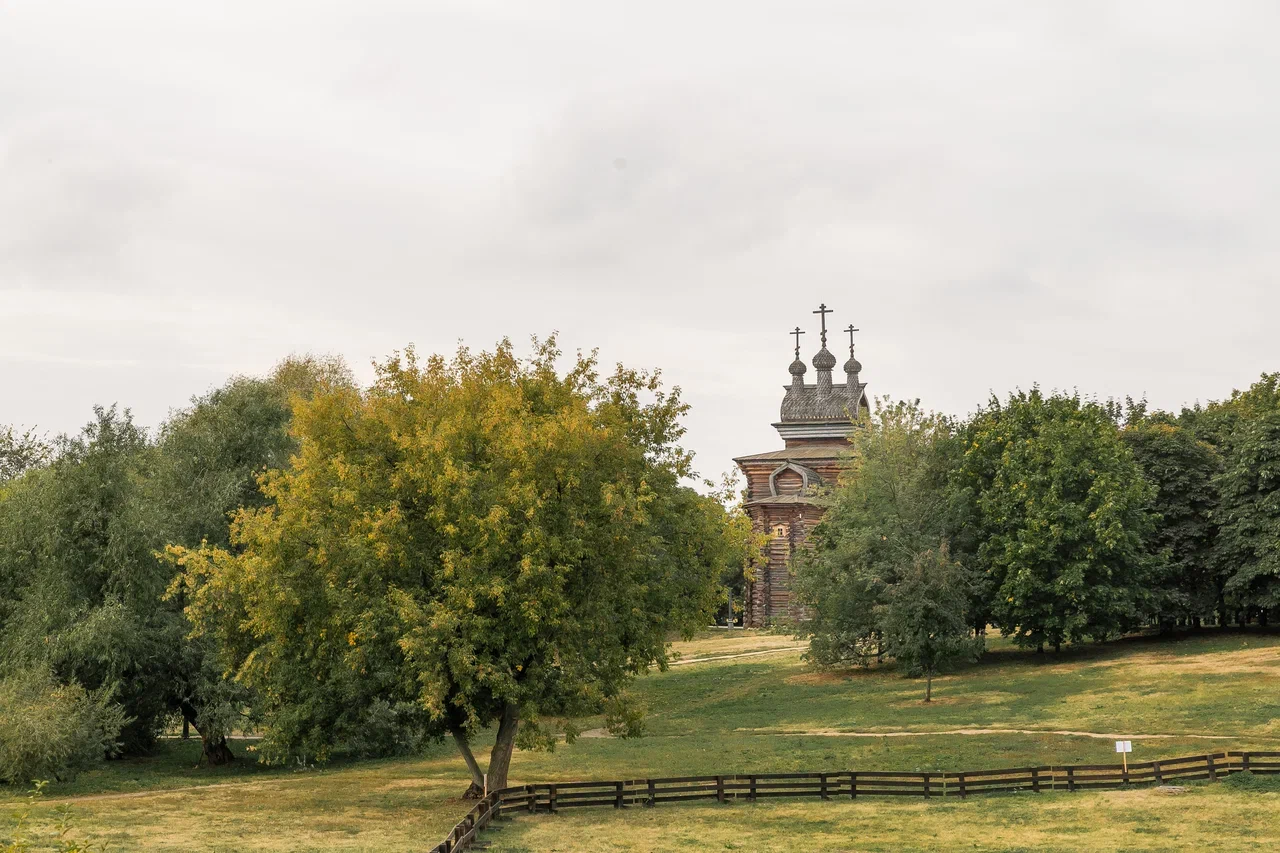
[{"left": 0, "top": 339, "right": 753, "bottom": 788}]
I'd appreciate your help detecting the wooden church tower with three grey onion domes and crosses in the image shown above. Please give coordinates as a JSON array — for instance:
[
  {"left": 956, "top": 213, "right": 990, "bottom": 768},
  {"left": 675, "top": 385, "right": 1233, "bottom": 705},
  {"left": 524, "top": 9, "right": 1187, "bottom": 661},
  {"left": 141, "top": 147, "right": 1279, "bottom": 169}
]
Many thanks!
[{"left": 733, "top": 305, "right": 870, "bottom": 628}]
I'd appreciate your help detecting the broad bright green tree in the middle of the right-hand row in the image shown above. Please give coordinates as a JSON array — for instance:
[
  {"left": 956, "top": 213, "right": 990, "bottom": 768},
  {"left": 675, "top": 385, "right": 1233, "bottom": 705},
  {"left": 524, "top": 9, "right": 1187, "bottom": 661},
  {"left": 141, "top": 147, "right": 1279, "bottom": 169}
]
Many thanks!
[{"left": 955, "top": 388, "right": 1152, "bottom": 649}]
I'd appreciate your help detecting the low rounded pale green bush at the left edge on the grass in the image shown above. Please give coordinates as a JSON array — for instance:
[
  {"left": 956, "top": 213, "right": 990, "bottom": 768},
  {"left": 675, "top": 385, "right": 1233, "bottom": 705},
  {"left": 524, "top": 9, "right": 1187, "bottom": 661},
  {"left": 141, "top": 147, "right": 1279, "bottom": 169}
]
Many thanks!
[{"left": 0, "top": 671, "right": 128, "bottom": 784}]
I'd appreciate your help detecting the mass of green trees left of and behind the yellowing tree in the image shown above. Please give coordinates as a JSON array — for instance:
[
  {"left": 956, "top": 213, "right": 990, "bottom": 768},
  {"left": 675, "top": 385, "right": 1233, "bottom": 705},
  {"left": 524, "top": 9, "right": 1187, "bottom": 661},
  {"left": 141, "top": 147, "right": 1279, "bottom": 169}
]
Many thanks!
[{"left": 0, "top": 357, "right": 351, "bottom": 753}]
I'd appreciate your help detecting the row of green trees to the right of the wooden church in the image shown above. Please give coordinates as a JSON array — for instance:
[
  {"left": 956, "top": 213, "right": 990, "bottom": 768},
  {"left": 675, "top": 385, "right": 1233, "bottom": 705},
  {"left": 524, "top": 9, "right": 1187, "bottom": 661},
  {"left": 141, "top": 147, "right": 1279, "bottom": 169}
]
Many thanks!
[{"left": 796, "top": 374, "right": 1280, "bottom": 691}]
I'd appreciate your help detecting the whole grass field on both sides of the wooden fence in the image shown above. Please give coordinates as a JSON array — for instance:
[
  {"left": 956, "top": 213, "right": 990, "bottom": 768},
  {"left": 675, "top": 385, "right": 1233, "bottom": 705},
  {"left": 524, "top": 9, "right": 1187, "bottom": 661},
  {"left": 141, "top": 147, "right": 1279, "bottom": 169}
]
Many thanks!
[{"left": 0, "top": 622, "right": 1280, "bottom": 853}]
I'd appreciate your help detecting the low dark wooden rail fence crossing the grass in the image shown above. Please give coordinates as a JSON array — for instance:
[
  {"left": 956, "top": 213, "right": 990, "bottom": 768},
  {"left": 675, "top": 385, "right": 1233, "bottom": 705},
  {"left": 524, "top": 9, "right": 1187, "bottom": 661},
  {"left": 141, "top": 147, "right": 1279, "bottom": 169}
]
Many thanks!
[{"left": 430, "top": 752, "right": 1280, "bottom": 853}]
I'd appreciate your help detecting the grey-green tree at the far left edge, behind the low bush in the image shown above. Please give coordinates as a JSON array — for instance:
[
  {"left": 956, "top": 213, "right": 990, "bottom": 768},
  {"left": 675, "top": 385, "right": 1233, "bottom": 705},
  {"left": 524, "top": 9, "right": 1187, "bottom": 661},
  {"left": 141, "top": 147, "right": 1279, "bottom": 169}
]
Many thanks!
[{"left": 0, "top": 407, "right": 174, "bottom": 753}]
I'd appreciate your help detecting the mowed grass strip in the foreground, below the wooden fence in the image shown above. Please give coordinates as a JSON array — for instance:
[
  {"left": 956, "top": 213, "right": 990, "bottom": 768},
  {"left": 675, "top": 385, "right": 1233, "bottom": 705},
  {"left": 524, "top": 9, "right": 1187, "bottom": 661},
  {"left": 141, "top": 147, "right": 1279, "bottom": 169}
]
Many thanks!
[{"left": 485, "top": 784, "right": 1280, "bottom": 853}]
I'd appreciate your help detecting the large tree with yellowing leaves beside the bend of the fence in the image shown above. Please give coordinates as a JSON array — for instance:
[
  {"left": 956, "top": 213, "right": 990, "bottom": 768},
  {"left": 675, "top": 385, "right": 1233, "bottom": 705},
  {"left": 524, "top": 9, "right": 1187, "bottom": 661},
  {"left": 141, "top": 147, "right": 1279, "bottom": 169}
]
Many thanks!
[{"left": 172, "top": 339, "right": 746, "bottom": 788}]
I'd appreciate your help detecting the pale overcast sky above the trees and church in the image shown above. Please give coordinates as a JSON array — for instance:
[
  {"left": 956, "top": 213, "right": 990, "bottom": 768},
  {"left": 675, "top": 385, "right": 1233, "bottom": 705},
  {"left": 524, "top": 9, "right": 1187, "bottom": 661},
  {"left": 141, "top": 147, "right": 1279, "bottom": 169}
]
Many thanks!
[{"left": 0, "top": 0, "right": 1280, "bottom": 474}]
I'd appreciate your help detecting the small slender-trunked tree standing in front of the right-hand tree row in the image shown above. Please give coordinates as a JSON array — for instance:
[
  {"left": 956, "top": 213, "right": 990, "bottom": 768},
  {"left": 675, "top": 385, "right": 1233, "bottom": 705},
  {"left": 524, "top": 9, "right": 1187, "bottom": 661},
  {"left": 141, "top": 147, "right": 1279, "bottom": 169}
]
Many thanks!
[{"left": 877, "top": 544, "right": 982, "bottom": 702}]
